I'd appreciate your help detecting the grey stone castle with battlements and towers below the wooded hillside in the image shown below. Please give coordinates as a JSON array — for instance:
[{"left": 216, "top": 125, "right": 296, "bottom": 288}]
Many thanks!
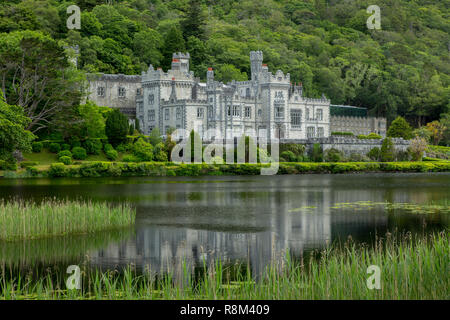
[{"left": 88, "top": 51, "right": 386, "bottom": 140}]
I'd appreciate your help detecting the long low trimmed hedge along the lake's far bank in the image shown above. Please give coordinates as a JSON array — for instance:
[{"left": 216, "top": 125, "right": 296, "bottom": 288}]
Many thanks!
[{"left": 7, "top": 161, "right": 450, "bottom": 177}]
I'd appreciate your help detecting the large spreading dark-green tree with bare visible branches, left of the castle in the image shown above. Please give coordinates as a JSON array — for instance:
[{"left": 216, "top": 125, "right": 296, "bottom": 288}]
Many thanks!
[{"left": 0, "top": 31, "right": 83, "bottom": 133}]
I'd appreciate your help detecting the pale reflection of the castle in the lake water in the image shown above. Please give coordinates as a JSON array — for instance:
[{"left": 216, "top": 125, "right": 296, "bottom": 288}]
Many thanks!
[{"left": 90, "top": 176, "right": 422, "bottom": 273}]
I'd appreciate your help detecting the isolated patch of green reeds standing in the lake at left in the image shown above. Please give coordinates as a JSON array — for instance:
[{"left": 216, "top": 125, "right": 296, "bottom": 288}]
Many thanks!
[{"left": 0, "top": 200, "right": 136, "bottom": 241}]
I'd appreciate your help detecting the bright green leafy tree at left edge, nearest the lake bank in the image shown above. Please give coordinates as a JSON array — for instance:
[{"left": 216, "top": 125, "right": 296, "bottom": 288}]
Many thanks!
[{"left": 0, "top": 92, "right": 35, "bottom": 162}]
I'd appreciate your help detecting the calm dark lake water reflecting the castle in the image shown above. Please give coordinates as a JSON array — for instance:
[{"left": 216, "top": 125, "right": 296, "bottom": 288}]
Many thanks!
[{"left": 0, "top": 173, "right": 450, "bottom": 272}]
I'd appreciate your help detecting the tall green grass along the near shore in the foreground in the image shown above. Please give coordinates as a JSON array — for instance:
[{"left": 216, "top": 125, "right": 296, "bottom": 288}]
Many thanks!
[{"left": 0, "top": 232, "right": 450, "bottom": 299}]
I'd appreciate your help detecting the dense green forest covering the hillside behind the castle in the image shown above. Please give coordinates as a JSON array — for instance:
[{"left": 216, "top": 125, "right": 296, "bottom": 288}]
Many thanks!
[{"left": 0, "top": 0, "right": 450, "bottom": 127}]
